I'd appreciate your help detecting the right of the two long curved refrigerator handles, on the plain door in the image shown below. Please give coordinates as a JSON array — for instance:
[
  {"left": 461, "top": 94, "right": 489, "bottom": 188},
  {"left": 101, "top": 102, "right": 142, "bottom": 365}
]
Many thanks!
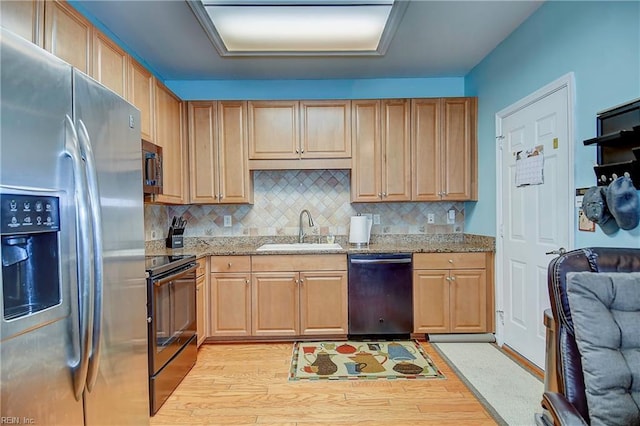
[{"left": 78, "top": 120, "right": 104, "bottom": 392}]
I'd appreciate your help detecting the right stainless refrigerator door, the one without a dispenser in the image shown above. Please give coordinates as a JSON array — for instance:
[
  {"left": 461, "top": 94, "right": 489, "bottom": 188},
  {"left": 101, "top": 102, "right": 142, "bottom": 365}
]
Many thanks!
[{"left": 73, "top": 70, "right": 149, "bottom": 426}]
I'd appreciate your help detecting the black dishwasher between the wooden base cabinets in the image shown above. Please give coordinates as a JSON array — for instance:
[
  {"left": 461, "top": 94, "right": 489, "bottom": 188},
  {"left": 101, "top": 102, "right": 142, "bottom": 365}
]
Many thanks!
[{"left": 348, "top": 253, "right": 413, "bottom": 339}]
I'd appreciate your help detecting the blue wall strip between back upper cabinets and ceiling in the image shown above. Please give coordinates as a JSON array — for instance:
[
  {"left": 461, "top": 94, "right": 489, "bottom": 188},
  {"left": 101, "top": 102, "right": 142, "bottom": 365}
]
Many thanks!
[{"left": 165, "top": 77, "right": 465, "bottom": 100}]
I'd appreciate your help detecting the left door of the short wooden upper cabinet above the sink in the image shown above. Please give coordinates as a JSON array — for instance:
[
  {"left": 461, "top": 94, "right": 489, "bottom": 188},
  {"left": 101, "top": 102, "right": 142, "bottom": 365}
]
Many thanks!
[{"left": 248, "top": 101, "right": 300, "bottom": 160}]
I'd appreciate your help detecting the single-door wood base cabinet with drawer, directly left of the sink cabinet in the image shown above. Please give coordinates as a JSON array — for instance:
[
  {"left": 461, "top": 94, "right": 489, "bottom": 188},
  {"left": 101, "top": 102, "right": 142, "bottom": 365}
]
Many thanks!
[{"left": 209, "top": 256, "right": 251, "bottom": 337}]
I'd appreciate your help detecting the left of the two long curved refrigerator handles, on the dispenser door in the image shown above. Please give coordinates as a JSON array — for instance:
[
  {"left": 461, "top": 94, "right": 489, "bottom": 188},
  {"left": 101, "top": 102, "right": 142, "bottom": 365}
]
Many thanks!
[{"left": 64, "top": 115, "right": 93, "bottom": 401}]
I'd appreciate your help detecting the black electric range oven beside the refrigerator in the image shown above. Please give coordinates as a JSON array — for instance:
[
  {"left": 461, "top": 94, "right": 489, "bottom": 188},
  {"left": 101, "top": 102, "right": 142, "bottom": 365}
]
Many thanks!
[{"left": 145, "top": 255, "right": 197, "bottom": 415}]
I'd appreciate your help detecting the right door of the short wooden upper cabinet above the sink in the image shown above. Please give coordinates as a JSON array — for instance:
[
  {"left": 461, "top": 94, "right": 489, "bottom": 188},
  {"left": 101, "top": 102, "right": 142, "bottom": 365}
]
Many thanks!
[{"left": 300, "top": 101, "right": 351, "bottom": 158}]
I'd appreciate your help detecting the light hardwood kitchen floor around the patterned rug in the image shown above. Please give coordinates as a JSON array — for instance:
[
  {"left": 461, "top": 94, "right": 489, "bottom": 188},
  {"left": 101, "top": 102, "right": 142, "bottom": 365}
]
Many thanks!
[{"left": 151, "top": 342, "right": 496, "bottom": 426}]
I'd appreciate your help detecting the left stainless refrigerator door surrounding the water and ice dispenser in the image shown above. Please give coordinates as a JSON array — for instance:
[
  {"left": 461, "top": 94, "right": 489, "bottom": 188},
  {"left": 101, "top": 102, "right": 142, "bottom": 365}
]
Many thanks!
[{"left": 0, "top": 28, "right": 83, "bottom": 425}]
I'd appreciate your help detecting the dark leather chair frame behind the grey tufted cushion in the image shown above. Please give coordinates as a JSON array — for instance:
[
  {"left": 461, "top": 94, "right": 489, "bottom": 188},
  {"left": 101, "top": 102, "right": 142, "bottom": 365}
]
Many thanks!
[{"left": 542, "top": 248, "right": 640, "bottom": 425}]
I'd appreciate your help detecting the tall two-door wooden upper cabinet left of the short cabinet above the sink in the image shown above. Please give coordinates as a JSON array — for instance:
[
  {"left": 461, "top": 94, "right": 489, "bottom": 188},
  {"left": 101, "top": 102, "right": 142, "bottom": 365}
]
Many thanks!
[{"left": 189, "top": 101, "right": 253, "bottom": 204}]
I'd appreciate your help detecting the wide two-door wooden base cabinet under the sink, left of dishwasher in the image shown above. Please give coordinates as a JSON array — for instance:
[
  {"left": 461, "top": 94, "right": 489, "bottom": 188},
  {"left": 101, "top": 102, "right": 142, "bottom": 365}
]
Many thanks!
[{"left": 252, "top": 255, "right": 348, "bottom": 336}]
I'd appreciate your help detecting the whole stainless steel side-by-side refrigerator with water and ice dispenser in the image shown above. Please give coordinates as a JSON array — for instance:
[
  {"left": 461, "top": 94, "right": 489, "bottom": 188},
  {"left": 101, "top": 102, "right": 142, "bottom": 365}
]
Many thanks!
[{"left": 0, "top": 30, "right": 149, "bottom": 426}]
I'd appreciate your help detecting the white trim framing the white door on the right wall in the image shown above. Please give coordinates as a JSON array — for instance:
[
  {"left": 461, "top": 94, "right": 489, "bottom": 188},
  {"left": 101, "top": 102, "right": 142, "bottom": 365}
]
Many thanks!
[{"left": 494, "top": 72, "right": 576, "bottom": 346}]
